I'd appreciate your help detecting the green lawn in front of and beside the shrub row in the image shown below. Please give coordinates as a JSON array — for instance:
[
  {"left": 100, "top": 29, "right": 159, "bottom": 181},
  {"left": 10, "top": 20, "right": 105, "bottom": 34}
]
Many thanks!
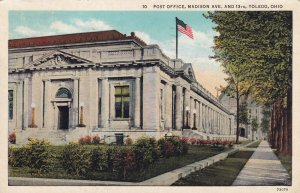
[{"left": 9, "top": 146, "right": 228, "bottom": 182}]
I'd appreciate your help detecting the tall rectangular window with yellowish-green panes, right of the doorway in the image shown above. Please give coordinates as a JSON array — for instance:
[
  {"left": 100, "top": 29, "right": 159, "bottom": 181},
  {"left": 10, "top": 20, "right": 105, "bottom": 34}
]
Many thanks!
[{"left": 115, "top": 86, "right": 130, "bottom": 118}]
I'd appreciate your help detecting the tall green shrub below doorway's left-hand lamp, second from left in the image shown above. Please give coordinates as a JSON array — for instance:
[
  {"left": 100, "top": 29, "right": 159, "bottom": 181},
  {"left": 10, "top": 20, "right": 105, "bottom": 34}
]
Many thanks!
[{"left": 25, "top": 139, "right": 51, "bottom": 173}]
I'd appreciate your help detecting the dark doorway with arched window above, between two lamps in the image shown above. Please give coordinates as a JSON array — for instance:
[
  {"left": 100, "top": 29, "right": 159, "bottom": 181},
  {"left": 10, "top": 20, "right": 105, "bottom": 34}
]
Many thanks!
[{"left": 55, "top": 87, "right": 72, "bottom": 130}]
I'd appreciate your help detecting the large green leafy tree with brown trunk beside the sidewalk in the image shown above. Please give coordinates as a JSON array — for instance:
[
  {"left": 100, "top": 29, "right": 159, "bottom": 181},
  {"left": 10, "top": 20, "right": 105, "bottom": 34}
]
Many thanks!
[{"left": 205, "top": 11, "right": 292, "bottom": 154}]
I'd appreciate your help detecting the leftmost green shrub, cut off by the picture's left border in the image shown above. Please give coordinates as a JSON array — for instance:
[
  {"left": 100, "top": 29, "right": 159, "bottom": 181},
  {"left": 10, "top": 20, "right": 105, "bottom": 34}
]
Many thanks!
[{"left": 8, "top": 147, "right": 28, "bottom": 167}]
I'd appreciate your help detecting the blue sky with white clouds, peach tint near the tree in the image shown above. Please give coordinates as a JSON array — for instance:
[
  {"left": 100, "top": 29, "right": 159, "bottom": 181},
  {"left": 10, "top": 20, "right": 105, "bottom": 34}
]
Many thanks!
[{"left": 9, "top": 11, "right": 225, "bottom": 94}]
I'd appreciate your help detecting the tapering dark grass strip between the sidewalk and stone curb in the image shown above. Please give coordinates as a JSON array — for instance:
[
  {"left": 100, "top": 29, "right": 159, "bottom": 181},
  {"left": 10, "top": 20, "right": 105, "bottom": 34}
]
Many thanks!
[{"left": 173, "top": 141, "right": 260, "bottom": 186}]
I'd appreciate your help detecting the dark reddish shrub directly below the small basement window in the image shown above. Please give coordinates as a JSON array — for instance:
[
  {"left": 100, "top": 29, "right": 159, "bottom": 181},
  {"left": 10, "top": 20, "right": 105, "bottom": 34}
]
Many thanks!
[{"left": 112, "top": 147, "right": 137, "bottom": 179}]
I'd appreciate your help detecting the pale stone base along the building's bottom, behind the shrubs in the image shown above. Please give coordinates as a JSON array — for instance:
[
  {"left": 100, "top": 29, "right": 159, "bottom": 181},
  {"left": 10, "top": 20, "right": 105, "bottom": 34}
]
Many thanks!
[{"left": 12, "top": 127, "right": 248, "bottom": 145}]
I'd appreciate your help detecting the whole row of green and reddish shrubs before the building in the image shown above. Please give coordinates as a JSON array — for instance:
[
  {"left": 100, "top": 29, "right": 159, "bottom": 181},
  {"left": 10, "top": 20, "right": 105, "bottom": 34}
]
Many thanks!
[{"left": 9, "top": 136, "right": 188, "bottom": 179}]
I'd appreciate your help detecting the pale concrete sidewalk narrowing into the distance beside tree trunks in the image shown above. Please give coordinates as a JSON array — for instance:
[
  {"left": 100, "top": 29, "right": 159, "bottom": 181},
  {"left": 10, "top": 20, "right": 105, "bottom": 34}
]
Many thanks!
[{"left": 232, "top": 141, "right": 292, "bottom": 186}]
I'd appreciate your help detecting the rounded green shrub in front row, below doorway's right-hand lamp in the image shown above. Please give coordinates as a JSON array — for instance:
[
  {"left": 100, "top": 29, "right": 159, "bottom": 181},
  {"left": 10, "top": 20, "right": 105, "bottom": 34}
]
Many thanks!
[{"left": 60, "top": 143, "right": 90, "bottom": 176}]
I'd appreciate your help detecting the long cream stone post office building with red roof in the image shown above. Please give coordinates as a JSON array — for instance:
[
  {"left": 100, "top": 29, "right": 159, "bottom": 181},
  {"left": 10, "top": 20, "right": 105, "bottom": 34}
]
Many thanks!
[{"left": 8, "top": 30, "right": 234, "bottom": 143}]
